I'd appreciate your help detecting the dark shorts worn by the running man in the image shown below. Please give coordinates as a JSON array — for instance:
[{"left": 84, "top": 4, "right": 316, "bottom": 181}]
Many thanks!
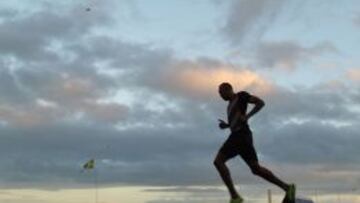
[{"left": 219, "top": 129, "right": 258, "bottom": 165}]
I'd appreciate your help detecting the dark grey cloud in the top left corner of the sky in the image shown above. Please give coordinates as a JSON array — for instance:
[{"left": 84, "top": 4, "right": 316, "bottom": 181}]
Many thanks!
[{"left": 0, "top": 1, "right": 111, "bottom": 61}]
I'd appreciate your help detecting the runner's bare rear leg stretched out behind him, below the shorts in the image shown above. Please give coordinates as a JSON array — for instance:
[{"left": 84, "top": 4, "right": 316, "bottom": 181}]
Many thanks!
[{"left": 249, "top": 161, "right": 290, "bottom": 192}]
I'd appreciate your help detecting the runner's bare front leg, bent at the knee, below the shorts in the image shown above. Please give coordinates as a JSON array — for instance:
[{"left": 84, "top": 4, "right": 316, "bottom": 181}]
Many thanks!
[{"left": 214, "top": 152, "right": 239, "bottom": 199}]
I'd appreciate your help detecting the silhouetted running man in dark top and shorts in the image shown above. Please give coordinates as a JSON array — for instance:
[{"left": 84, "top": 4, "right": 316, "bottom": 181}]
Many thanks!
[{"left": 214, "top": 82, "right": 295, "bottom": 203}]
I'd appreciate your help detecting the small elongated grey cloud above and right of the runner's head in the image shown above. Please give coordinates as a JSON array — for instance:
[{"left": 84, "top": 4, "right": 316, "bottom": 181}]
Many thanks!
[{"left": 256, "top": 41, "right": 338, "bottom": 70}]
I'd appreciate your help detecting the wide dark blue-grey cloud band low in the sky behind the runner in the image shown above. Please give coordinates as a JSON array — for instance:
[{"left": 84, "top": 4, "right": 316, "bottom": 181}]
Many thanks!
[{"left": 1, "top": 82, "right": 360, "bottom": 187}]
